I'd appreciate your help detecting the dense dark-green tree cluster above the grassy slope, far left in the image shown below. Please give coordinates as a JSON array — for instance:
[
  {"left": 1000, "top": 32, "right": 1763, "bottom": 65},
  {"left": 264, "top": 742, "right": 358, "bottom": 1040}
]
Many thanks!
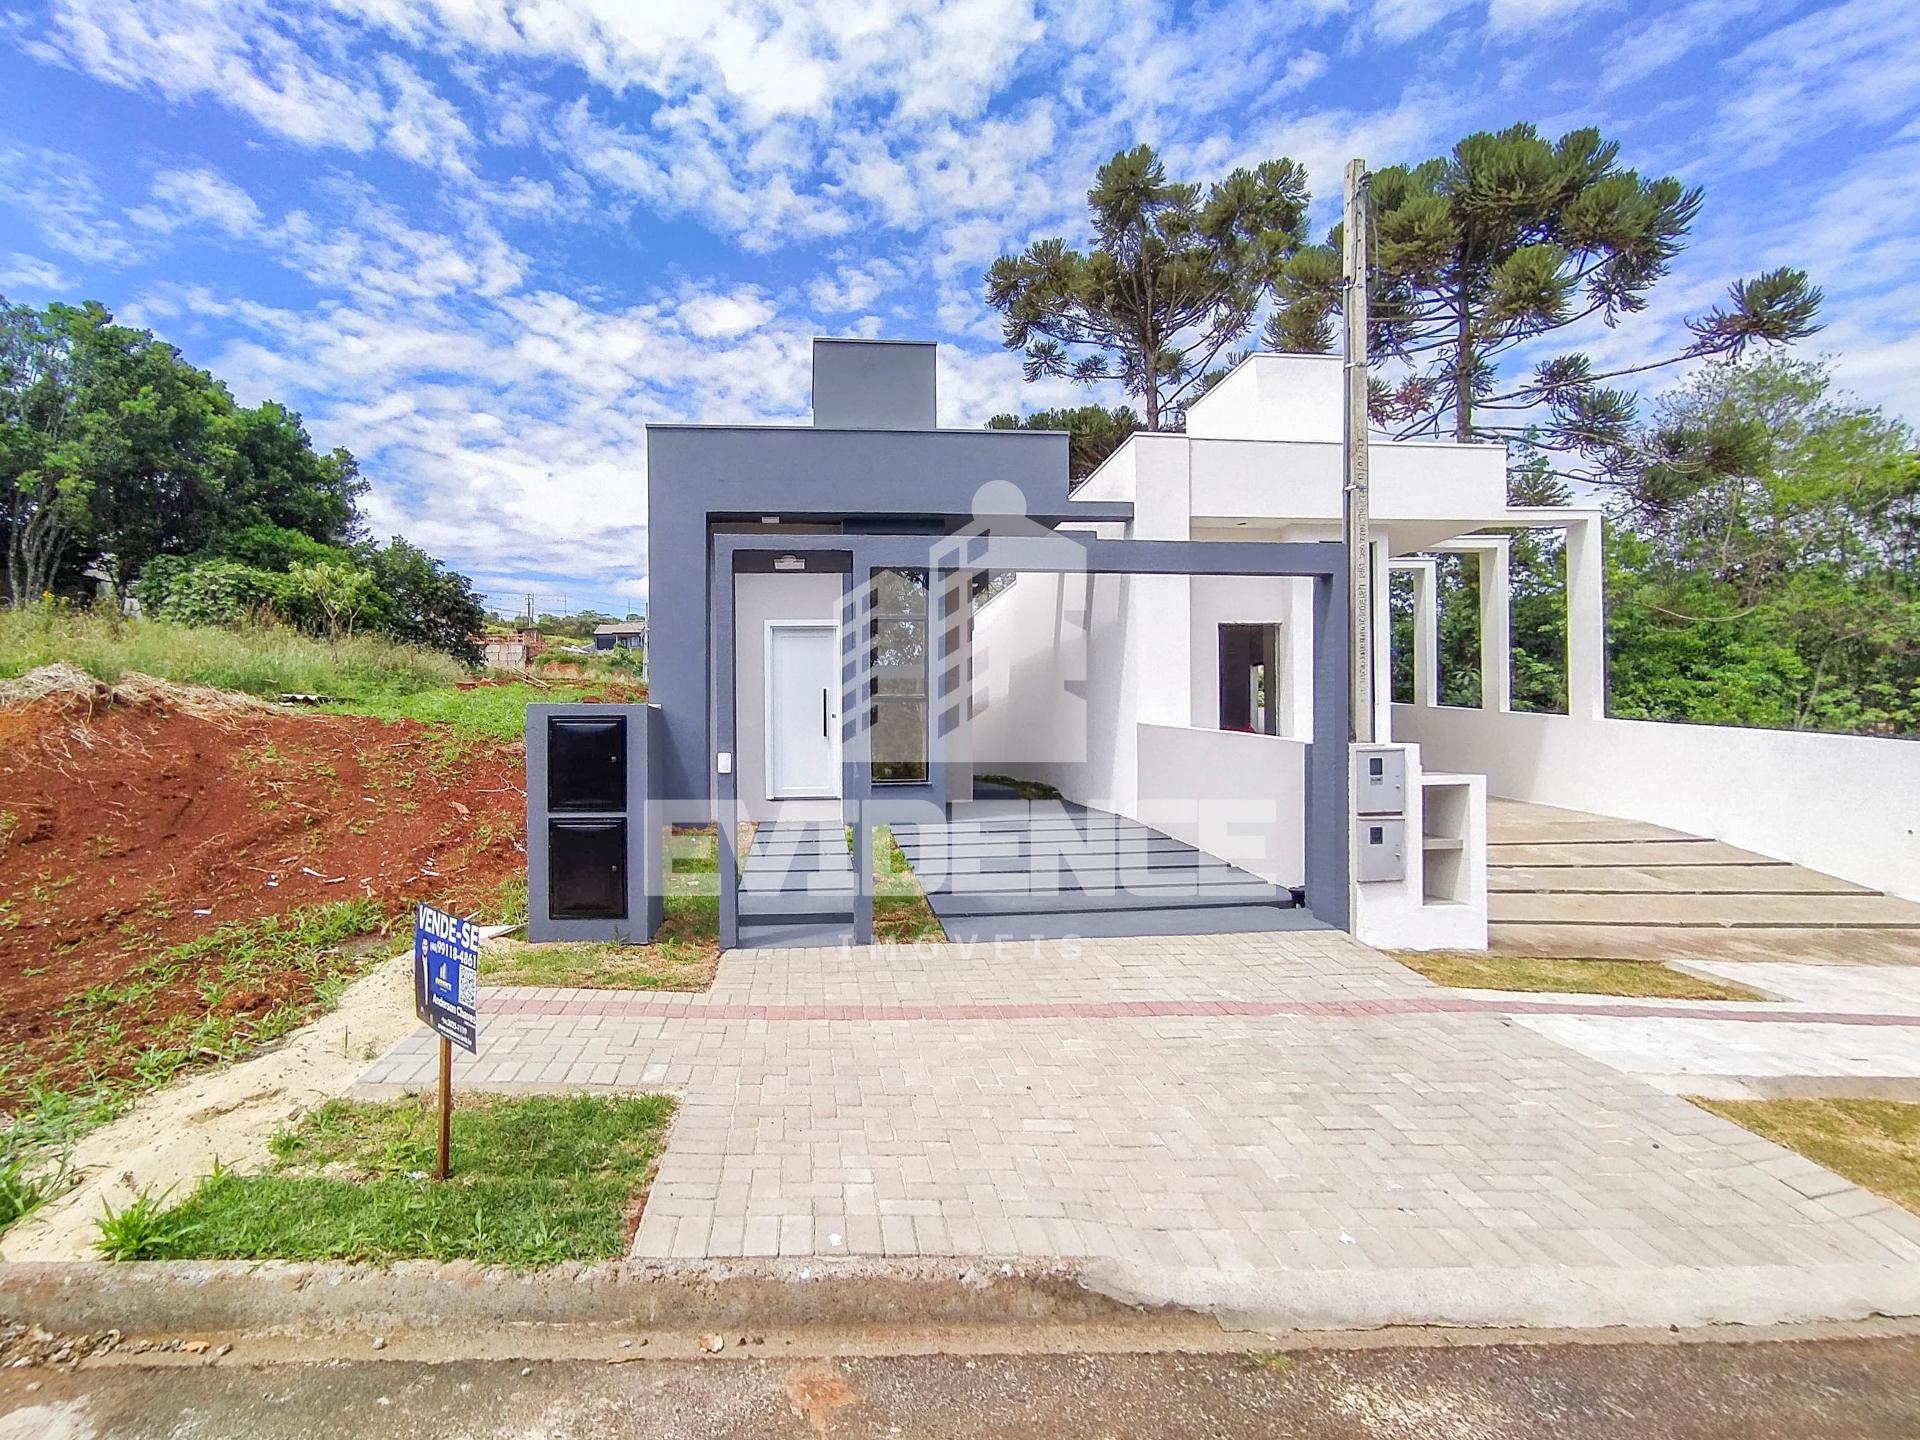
[{"left": 0, "top": 300, "right": 482, "bottom": 662}]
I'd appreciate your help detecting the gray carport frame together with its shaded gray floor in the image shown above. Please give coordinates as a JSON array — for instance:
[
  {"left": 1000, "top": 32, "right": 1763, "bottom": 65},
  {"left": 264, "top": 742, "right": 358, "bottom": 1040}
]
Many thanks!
[{"left": 708, "top": 526, "right": 1350, "bottom": 948}]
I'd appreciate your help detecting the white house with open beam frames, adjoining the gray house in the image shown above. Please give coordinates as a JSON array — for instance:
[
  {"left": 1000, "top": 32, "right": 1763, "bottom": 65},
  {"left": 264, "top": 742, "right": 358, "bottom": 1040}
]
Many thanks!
[{"left": 973, "top": 355, "right": 1603, "bottom": 948}]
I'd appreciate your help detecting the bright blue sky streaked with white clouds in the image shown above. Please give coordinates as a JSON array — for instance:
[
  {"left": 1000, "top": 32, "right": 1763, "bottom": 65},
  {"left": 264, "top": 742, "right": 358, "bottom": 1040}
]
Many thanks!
[{"left": 0, "top": 0, "right": 1920, "bottom": 611}]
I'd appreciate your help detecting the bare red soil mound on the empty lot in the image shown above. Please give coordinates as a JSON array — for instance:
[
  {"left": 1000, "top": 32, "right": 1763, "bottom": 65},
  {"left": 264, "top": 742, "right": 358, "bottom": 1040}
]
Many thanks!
[{"left": 0, "top": 695, "right": 524, "bottom": 1106}]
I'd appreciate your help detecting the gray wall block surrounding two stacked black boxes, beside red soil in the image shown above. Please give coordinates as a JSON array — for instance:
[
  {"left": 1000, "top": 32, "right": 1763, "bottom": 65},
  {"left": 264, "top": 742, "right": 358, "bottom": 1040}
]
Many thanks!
[{"left": 526, "top": 705, "right": 666, "bottom": 943}]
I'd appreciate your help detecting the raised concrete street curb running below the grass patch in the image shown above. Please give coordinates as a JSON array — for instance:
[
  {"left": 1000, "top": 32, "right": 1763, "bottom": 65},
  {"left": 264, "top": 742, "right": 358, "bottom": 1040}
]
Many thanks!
[{"left": 0, "top": 1260, "right": 1194, "bottom": 1338}]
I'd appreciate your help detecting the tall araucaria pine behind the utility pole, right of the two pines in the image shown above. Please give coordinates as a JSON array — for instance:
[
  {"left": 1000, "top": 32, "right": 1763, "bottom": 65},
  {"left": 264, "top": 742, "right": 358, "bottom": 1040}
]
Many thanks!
[{"left": 1263, "top": 125, "right": 1820, "bottom": 472}]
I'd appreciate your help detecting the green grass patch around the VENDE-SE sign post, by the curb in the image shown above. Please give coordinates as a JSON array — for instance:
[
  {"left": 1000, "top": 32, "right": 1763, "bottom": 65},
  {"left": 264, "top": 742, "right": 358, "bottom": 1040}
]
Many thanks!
[{"left": 100, "top": 1094, "right": 674, "bottom": 1265}]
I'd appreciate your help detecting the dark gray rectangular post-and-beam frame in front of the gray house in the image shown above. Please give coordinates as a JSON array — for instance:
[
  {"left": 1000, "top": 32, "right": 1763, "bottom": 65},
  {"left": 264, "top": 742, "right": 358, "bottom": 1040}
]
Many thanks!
[{"left": 707, "top": 530, "right": 1352, "bottom": 950}]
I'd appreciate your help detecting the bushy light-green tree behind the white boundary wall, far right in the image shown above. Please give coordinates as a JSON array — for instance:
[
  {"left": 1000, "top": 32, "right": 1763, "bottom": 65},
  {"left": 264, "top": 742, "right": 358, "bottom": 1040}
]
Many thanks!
[{"left": 1609, "top": 357, "right": 1920, "bottom": 733}]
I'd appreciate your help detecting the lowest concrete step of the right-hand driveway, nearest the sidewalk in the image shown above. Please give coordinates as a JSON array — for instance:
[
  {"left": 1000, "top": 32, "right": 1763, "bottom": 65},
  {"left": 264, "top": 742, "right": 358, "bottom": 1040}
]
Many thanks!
[{"left": 1486, "top": 924, "right": 1920, "bottom": 966}]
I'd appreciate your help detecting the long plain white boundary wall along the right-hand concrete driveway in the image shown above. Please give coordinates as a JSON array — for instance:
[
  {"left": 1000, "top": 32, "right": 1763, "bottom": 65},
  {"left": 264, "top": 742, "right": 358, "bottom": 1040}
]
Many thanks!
[{"left": 1394, "top": 705, "right": 1920, "bottom": 900}]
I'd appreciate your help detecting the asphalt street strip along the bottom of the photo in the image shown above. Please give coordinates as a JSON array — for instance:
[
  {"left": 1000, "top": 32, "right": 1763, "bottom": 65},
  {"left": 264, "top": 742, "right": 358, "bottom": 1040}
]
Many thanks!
[{"left": 0, "top": 1336, "right": 1920, "bottom": 1440}]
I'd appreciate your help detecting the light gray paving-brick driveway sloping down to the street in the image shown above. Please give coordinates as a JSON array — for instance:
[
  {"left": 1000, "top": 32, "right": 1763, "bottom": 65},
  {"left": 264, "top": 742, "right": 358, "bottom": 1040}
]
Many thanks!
[{"left": 363, "top": 933, "right": 1920, "bottom": 1323}]
